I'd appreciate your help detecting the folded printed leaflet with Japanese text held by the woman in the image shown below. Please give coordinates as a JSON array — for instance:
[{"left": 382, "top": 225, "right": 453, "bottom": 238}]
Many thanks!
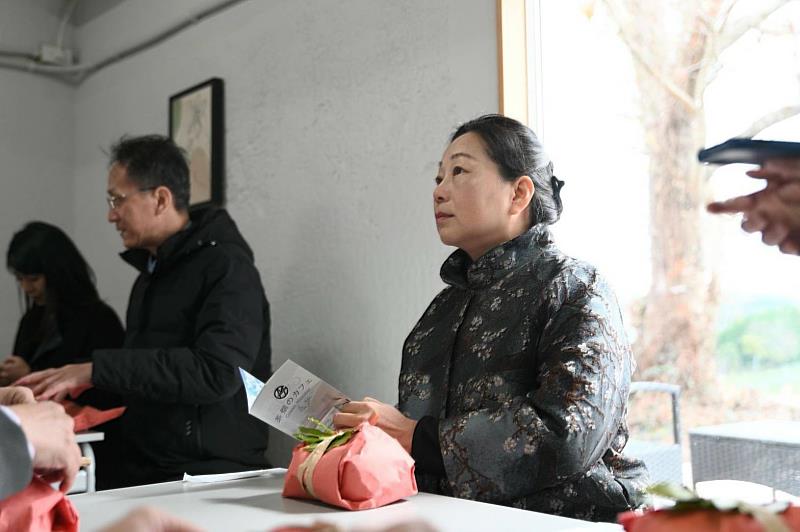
[{"left": 239, "top": 360, "right": 350, "bottom": 437}]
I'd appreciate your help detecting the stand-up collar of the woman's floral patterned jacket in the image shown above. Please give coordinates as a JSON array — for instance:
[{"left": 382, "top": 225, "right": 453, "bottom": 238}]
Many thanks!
[{"left": 440, "top": 224, "right": 553, "bottom": 290}]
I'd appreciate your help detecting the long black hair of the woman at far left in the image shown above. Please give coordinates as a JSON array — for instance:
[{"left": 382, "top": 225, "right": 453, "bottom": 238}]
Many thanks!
[{"left": 6, "top": 222, "right": 99, "bottom": 317}]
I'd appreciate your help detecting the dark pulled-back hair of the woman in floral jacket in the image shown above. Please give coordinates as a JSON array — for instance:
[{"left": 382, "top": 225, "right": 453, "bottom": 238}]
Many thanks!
[{"left": 450, "top": 115, "right": 564, "bottom": 226}]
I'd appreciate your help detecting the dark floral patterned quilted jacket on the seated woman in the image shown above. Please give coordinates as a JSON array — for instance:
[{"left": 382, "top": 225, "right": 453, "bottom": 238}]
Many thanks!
[{"left": 398, "top": 225, "right": 648, "bottom": 521}]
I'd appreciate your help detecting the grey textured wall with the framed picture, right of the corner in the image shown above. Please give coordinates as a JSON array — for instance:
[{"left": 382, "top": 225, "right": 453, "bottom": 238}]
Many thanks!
[{"left": 73, "top": 0, "right": 498, "bottom": 464}]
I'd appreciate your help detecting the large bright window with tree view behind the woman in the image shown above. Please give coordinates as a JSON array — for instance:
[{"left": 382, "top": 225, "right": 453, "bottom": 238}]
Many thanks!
[{"left": 527, "top": 0, "right": 800, "bottom": 498}]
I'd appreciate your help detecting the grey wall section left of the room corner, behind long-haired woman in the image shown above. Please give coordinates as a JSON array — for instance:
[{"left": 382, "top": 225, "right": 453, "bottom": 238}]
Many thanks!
[{"left": 0, "top": 0, "right": 74, "bottom": 350}]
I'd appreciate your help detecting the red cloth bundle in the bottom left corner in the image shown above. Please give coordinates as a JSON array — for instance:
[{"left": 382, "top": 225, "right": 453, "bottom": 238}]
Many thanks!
[{"left": 0, "top": 475, "right": 78, "bottom": 532}]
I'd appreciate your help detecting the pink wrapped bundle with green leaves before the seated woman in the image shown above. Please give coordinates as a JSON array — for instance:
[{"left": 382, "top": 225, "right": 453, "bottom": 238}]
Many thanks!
[{"left": 283, "top": 423, "right": 417, "bottom": 510}]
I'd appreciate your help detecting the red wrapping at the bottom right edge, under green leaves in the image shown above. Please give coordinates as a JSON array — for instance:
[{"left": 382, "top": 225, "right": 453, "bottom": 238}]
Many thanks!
[{"left": 617, "top": 506, "right": 800, "bottom": 532}]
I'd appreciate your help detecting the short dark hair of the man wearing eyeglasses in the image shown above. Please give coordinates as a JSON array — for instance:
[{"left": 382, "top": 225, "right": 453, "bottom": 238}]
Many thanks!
[{"left": 109, "top": 135, "right": 191, "bottom": 211}]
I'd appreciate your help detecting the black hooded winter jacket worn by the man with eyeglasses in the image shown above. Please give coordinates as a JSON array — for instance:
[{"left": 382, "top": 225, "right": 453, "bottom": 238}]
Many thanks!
[{"left": 92, "top": 209, "right": 270, "bottom": 482}]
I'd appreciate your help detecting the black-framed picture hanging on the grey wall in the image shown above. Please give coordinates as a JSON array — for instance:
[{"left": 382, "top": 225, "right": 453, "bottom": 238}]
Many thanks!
[{"left": 169, "top": 78, "right": 225, "bottom": 210}]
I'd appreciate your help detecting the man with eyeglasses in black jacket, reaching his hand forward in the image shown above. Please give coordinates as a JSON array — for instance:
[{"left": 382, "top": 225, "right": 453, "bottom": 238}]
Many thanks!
[{"left": 19, "top": 135, "right": 270, "bottom": 489}]
